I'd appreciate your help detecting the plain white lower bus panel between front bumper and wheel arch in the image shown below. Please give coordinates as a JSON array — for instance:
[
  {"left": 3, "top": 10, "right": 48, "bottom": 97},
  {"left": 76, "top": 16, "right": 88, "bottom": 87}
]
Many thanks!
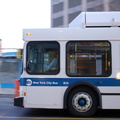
[{"left": 24, "top": 86, "right": 63, "bottom": 108}]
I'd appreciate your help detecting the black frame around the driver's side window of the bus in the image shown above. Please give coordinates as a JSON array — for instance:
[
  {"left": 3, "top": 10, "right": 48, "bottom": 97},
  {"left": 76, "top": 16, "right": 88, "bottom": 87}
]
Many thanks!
[{"left": 25, "top": 41, "right": 60, "bottom": 75}]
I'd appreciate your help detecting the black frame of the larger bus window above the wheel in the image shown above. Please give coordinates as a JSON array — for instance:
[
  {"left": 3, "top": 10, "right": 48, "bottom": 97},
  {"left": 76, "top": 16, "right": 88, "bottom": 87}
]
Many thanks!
[{"left": 66, "top": 40, "right": 112, "bottom": 77}]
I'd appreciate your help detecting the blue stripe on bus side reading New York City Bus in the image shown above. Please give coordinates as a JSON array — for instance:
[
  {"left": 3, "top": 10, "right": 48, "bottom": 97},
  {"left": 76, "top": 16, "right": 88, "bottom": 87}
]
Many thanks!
[{"left": 20, "top": 78, "right": 120, "bottom": 86}]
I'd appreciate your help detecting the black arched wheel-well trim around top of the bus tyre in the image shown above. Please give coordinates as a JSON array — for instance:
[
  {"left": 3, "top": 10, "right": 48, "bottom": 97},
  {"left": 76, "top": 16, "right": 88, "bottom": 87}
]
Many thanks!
[{"left": 64, "top": 84, "right": 102, "bottom": 108}]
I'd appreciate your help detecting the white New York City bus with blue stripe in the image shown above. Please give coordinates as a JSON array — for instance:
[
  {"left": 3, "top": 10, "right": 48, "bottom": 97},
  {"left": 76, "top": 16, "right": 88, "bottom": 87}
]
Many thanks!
[{"left": 14, "top": 12, "right": 120, "bottom": 117}]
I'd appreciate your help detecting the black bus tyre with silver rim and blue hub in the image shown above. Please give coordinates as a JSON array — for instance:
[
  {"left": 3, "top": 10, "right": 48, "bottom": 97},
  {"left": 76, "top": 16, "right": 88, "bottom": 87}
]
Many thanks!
[{"left": 68, "top": 86, "right": 98, "bottom": 117}]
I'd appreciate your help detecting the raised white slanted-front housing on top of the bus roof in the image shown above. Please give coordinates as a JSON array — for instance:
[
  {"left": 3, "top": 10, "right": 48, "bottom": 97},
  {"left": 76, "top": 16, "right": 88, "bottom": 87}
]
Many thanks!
[{"left": 69, "top": 12, "right": 120, "bottom": 28}]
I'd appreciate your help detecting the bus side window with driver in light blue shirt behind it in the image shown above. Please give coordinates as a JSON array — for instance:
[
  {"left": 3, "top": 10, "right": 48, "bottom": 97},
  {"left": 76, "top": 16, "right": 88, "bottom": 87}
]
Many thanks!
[{"left": 26, "top": 42, "right": 59, "bottom": 74}]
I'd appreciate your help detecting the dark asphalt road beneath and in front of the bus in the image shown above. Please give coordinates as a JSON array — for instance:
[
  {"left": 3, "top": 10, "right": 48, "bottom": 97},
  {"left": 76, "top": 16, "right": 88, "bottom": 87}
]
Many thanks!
[{"left": 0, "top": 95, "right": 120, "bottom": 120}]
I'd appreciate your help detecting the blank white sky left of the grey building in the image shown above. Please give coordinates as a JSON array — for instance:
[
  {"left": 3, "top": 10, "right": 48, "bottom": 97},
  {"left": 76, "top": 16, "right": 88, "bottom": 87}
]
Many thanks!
[{"left": 0, "top": 0, "right": 51, "bottom": 48}]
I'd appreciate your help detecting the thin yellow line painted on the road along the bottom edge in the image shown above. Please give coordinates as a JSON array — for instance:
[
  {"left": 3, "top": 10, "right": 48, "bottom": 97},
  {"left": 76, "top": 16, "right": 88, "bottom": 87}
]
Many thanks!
[{"left": 0, "top": 116, "right": 120, "bottom": 120}]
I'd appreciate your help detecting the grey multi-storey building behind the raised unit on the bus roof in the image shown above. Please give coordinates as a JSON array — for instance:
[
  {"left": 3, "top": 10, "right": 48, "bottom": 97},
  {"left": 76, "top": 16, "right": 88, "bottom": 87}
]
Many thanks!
[{"left": 51, "top": 0, "right": 120, "bottom": 27}]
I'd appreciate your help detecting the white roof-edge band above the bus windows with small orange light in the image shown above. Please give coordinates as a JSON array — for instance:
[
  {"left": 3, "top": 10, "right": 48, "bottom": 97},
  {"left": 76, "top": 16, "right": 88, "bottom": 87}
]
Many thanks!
[{"left": 23, "top": 27, "right": 120, "bottom": 41}]
